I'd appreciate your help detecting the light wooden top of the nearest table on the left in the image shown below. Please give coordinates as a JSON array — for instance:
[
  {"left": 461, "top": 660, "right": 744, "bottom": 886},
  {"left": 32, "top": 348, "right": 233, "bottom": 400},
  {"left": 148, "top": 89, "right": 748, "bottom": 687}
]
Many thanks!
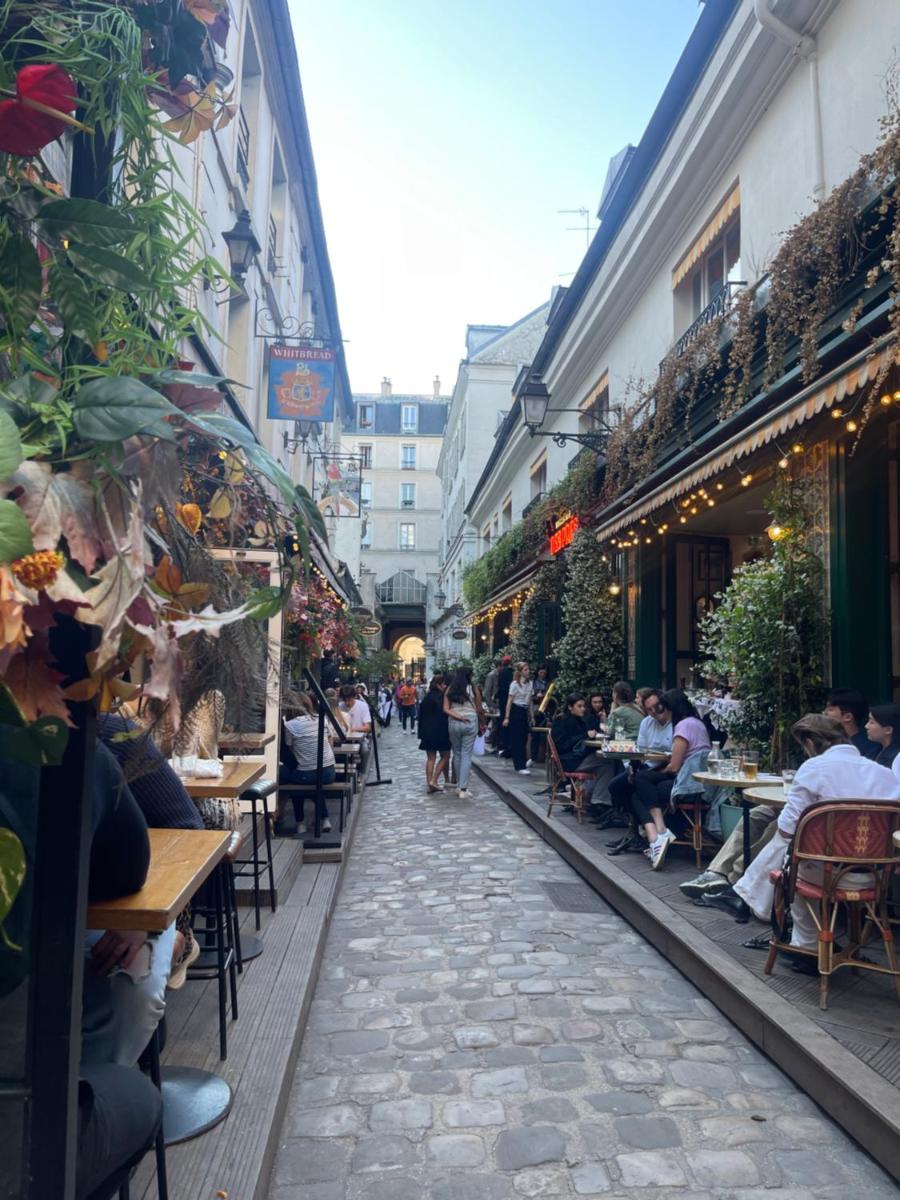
[{"left": 86, "top": 829, "right": 232, "bottom": 934}]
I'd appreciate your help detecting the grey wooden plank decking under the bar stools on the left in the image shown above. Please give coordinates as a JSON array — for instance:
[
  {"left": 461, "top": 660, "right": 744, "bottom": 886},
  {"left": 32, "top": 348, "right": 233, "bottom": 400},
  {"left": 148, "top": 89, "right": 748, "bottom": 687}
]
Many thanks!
[{"left": 131, "top": 772, "right": 365, "bottom": 1200}]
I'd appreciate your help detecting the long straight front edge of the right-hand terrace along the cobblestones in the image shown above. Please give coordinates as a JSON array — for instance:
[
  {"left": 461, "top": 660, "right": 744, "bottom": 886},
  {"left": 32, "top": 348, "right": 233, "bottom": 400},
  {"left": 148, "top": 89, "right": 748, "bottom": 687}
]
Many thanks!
[{"left": 473, "top": 762, "right": 900, "bottom": 1180}]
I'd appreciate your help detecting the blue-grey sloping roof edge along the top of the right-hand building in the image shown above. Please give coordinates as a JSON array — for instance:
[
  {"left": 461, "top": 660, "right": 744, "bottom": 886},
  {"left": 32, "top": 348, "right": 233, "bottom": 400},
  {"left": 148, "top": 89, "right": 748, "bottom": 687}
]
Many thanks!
[{"left": 532, "top": 0, "right": 740, "bottom": 393}]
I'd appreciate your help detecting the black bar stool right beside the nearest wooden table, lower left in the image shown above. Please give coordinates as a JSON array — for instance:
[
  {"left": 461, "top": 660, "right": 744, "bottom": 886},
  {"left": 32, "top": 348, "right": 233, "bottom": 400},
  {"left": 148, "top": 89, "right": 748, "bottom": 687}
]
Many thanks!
[{"left": 187, "top": 829, "right": 244, "bottom": 1060}]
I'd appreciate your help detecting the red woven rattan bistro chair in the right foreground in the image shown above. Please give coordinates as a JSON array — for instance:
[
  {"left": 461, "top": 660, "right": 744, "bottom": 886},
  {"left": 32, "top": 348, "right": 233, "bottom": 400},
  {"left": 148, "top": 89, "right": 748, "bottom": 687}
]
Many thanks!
[{"left": 766, "top": 800, "right": 900, "bottom": 1009}]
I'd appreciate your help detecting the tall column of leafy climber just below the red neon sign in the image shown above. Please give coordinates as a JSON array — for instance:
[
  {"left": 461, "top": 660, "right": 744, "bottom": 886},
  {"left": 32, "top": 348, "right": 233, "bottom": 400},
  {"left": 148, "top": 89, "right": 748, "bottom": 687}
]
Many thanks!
[{"left": 553, "top": 529, "right": 624, "bottom": 696}]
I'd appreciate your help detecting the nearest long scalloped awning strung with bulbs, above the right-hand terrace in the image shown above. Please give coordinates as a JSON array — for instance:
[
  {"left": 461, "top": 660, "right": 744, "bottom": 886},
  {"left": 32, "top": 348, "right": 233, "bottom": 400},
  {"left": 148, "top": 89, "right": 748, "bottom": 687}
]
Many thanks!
[{"left": 596, "top": 341, "right": 900, "bottom": 541}]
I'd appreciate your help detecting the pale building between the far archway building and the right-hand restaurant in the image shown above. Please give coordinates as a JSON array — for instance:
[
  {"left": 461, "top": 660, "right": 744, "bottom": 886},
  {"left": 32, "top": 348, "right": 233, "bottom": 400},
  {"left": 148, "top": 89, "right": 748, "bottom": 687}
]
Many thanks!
[{"left": 430, "top": 304, "right": 550, "bottom": 654}]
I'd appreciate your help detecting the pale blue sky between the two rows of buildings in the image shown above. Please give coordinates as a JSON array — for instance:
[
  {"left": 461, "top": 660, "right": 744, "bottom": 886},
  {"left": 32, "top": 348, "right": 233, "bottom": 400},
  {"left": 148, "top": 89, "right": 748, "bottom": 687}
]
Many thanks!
[{"left": 289, "top": 0, "right": 701, "bottom": 395}]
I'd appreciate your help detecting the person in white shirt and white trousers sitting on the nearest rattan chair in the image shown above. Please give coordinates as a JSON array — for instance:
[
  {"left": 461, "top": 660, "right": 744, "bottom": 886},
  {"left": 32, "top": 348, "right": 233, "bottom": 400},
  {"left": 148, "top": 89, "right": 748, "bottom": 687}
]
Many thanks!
[{"left": 713, "top": 713, "right": 900, "bottom": 955}]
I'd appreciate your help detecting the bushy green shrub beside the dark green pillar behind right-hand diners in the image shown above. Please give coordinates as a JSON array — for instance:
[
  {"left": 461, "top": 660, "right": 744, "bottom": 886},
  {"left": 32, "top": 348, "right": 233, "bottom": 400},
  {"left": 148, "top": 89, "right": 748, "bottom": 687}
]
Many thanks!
[{"left": 701, "top": 479, "right": 828, "bottom": 768}]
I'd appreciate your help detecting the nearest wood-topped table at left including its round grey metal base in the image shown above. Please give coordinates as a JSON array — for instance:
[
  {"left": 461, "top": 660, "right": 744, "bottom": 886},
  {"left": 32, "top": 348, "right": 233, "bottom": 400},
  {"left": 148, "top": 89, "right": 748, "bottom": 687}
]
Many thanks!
[{"left": 86, "top": 829, "right": 232, "bottom": 1146}]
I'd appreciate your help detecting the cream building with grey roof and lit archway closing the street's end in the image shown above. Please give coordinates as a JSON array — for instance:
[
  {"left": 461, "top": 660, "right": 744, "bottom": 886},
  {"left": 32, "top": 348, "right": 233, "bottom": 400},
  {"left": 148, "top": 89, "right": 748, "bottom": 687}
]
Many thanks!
[{"left": 342, "top": 379, "right": 449, "bottom": 673}]
